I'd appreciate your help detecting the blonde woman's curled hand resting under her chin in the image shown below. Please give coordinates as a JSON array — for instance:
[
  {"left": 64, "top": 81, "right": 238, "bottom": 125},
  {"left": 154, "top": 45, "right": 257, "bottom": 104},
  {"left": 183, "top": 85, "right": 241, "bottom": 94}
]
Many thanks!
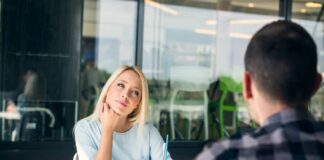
[{"left": 99, "top": 103, "right": 120, "bottom": 132}]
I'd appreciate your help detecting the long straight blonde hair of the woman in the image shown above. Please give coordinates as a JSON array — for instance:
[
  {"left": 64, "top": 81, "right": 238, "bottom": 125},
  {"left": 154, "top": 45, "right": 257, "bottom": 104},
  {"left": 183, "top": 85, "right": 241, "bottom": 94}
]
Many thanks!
[{"left": 86, "top": 65, "right": 149, "bottom": 131}]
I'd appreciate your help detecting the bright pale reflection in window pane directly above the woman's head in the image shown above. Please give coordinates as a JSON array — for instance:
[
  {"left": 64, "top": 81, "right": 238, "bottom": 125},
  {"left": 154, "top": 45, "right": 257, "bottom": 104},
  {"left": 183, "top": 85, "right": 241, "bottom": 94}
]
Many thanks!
[{"left": 83, "top": 0, "right": 137, "bottom": 73}]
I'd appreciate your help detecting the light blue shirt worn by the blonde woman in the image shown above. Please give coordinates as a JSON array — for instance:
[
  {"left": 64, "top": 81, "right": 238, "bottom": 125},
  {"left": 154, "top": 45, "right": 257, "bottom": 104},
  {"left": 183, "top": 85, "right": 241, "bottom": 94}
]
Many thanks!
[{"left": 74, "top": 119, "right": 171, "bottom": 160}]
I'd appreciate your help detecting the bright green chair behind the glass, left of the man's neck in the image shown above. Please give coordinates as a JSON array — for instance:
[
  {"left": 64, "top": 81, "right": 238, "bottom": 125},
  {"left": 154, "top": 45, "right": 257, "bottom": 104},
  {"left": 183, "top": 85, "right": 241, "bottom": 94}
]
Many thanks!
[{"left": 218, "top": 76, "right": 242, "bottom": 137}]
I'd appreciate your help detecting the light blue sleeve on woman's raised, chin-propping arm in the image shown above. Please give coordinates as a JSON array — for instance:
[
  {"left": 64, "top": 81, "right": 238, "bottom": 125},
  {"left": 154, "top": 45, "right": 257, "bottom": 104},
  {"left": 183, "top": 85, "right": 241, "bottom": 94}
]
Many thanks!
[{"left": 74, "top": 120, "right": 98, "bottom": 160}]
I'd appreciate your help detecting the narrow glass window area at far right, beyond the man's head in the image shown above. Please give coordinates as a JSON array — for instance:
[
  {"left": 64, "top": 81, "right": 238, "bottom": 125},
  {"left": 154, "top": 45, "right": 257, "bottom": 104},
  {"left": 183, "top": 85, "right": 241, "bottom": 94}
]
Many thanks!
[{"left": 292, "top": 0, "right": 324, "bottom": 120}]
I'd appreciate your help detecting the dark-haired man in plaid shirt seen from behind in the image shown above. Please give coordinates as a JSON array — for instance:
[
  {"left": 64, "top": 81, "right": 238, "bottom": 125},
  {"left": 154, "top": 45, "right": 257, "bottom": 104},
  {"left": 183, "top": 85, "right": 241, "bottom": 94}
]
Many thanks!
[{"left": 197, "top": 21, "right": 324, "bottom": 160}]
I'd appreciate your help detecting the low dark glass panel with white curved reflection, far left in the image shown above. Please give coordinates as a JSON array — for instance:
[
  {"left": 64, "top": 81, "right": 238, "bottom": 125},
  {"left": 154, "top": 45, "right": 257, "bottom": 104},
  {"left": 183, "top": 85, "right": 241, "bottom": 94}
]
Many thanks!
[{"left": 0, "top": 99, "right": 77, "bottom": 142}]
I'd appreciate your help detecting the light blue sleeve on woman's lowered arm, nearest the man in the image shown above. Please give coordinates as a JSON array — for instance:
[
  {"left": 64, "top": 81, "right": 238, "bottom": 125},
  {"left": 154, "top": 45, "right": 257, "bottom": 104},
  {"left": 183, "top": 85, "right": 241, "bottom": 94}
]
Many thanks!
[{"left": 149, "top": 124, "right": 172, "bottom": 160}]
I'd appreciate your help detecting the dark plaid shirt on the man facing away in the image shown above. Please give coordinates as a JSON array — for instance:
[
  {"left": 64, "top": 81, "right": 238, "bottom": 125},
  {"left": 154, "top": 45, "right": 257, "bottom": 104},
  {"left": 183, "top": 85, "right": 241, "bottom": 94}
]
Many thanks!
[{"left": 196, "top": 107, "right": 324, "bottom": 160}]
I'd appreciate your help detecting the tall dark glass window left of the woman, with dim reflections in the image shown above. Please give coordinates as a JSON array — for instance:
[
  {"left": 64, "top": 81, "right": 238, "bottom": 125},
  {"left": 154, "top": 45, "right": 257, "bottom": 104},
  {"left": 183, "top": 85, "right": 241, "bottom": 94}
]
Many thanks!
[{"left": 0, "top": 1, "right": 82, "bottom": 141}]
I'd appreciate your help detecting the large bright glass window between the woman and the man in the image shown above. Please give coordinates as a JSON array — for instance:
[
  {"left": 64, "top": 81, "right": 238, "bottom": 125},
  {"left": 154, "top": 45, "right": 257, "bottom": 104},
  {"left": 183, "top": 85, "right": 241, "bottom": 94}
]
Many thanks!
[{"left": 143, "top": 0, "right": 279, "bottom": 140}]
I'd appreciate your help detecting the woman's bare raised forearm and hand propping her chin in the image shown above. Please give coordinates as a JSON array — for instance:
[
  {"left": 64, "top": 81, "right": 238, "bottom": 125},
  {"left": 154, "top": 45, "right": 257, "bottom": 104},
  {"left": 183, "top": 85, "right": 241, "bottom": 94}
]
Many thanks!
[{"left": 96, "top": 103, "right": 119, "bottom": 160}]
